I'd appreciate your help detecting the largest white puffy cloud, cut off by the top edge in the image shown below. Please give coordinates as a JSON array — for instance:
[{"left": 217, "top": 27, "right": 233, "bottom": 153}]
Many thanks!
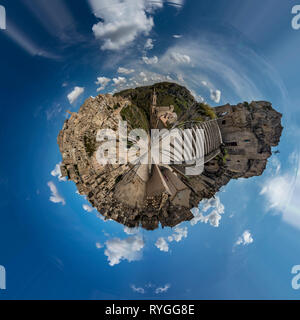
[{"left": 89, "top": 0, "right": 163, "bottom": 50}]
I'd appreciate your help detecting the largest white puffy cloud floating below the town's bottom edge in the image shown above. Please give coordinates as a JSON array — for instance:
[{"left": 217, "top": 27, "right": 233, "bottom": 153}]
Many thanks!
[{"left": 104, "top": 235, "right": 145, "bottom": 266}]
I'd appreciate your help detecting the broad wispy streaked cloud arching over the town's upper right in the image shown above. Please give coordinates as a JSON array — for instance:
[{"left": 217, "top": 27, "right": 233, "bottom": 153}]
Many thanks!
[{"left": 122, "top": 34, "right": 284, "bottom": 103}]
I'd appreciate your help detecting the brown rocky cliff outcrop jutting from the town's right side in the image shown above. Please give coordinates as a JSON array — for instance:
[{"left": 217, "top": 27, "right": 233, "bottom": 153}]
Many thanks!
[{"left": 186, "top": 101, "right": 283, "bottom": 206}]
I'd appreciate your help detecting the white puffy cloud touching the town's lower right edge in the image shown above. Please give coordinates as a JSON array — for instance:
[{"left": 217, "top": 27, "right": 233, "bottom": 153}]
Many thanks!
[{"left": 191, "top": 197, "right": 225, "bottom": 228}]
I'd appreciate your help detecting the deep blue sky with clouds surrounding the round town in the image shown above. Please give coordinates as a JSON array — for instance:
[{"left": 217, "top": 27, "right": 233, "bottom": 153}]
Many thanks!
[{"left": 0, "top": 0, "right": 300, "bottom": 299}]
